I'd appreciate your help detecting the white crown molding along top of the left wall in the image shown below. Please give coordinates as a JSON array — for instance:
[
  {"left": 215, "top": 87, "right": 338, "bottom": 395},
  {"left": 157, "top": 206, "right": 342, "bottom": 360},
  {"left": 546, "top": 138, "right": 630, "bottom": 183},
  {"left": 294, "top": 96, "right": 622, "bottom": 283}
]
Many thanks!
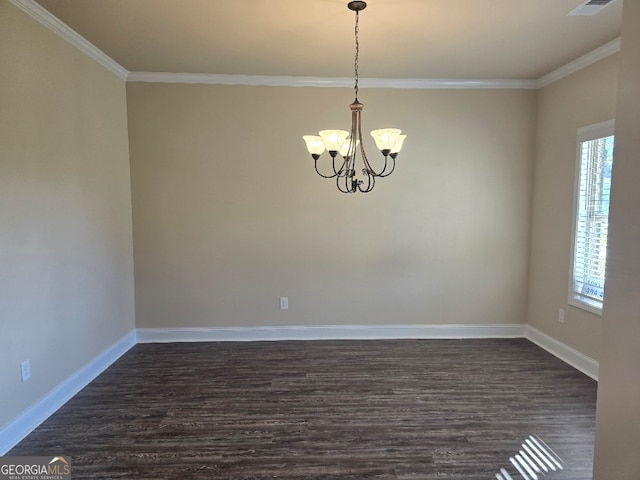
[{"left": 9, "top": 0, "right": 129, "bottom": 80}]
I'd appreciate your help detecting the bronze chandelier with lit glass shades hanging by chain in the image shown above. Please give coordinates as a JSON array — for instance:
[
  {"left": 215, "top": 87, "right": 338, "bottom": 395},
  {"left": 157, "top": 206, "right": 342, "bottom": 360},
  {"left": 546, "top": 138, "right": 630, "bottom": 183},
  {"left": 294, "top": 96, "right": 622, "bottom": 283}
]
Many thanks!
[{"left": 302, "top": 1, "right": 407, "bottom": 193}]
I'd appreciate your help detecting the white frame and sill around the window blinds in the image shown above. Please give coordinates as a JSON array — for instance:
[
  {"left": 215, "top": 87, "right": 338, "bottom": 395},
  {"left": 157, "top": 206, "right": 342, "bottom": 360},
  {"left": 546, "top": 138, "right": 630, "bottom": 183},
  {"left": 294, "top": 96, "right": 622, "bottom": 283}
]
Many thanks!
[{"left": 568, "top": 120, "right": 615, "bottom": 315}]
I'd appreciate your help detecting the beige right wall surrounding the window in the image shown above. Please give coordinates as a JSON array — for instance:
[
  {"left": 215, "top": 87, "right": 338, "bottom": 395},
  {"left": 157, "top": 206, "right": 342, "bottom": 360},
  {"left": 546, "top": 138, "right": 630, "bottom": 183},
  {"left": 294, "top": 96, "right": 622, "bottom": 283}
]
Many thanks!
[{"left": 528, "top": 55, "right": 619, "bottom": 360}]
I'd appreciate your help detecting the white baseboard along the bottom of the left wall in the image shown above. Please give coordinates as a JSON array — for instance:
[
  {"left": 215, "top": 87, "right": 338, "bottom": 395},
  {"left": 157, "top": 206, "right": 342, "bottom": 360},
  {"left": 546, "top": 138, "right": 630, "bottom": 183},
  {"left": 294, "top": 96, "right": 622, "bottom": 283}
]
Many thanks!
[{"left": 0, "top": 330, "right": 136, "bottom": 456}]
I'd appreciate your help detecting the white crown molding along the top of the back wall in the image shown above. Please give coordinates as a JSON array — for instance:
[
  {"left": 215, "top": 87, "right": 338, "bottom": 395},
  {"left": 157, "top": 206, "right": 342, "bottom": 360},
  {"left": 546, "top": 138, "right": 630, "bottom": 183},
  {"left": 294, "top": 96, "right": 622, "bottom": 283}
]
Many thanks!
[{"left": 127, "top": 72, "right": 537, "bottom": 89}]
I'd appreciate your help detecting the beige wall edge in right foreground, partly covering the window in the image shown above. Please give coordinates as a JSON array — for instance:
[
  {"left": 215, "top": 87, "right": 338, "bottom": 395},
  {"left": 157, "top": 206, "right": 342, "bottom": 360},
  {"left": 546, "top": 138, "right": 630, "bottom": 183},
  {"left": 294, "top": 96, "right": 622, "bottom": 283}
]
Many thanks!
[{"left": 594, "top": 1, "right": 640, "bottom": 480}]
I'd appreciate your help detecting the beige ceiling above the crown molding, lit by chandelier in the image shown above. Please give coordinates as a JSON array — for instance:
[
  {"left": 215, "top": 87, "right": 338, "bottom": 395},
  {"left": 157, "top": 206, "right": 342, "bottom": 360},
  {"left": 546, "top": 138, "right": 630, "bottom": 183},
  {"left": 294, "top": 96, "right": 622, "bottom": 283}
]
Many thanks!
[{"left": 32, "top": 0, "right": 623, "bottom": 80}]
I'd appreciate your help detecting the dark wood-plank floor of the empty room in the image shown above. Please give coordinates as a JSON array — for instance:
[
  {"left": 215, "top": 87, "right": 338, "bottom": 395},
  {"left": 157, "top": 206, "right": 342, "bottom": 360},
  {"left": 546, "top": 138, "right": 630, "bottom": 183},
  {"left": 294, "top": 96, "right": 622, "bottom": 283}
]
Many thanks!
[{"left": 8, "top": 339, "right": 596, "bottom": 480}]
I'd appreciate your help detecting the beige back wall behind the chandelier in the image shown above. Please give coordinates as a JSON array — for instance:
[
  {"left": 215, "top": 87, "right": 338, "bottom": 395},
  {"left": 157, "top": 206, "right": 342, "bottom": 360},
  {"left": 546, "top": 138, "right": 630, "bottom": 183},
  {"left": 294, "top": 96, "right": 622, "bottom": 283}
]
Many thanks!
[{"left": 127, "top": 83, "right": 536, "bottom": 327}]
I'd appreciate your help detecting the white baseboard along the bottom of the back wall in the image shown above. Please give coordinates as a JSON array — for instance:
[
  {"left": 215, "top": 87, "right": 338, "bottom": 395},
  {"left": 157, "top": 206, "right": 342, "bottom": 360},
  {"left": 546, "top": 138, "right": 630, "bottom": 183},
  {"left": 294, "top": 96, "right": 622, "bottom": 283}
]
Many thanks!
[{"left": 137, "top": 324, "right": 526, "bottom": 343}]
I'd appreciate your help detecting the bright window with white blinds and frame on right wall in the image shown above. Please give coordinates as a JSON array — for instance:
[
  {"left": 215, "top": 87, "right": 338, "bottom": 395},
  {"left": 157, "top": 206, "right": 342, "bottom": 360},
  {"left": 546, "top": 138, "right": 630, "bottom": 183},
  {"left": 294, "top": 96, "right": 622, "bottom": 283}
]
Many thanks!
[{"left": 569, "top": 120, "right": 614, "bottom": 314}]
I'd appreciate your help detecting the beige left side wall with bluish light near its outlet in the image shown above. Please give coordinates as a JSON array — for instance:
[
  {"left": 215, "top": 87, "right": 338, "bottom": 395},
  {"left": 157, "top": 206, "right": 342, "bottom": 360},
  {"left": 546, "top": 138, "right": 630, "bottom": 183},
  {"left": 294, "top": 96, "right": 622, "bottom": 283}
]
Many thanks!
[{"left": 0, "top": 0, "right": 134, "bottom": 428}]
